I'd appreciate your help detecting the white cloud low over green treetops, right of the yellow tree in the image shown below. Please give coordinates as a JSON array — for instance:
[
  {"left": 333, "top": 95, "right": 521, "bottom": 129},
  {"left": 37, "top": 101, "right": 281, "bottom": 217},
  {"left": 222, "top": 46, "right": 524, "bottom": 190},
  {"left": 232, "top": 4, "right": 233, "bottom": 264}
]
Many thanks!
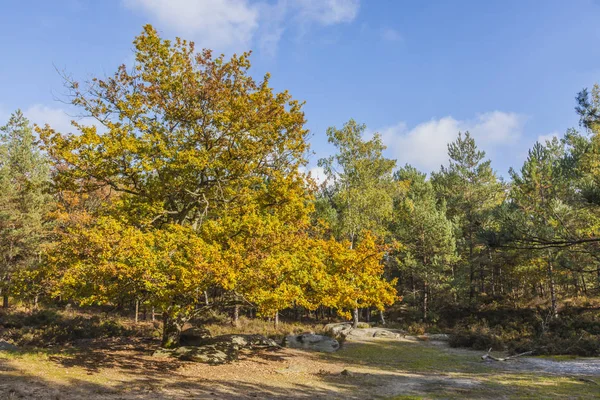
[{"left": 380, "top": 111, "right": 526, "bottom": 171}]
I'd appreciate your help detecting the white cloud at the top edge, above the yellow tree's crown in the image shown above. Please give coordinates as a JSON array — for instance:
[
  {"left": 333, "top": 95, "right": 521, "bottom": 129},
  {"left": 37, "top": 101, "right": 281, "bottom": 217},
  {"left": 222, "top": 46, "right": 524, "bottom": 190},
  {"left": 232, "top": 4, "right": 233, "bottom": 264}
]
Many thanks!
[{"left": 122, "top": 0, "right": 360, "bottom": 55}]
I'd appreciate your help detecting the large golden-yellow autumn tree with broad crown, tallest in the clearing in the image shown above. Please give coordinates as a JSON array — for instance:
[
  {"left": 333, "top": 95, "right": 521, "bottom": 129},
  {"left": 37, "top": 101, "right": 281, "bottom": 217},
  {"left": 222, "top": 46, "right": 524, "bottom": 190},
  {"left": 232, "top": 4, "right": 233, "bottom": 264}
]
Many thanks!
[{"left": 39, "top": 25, "right": 309, "bottom": 346}]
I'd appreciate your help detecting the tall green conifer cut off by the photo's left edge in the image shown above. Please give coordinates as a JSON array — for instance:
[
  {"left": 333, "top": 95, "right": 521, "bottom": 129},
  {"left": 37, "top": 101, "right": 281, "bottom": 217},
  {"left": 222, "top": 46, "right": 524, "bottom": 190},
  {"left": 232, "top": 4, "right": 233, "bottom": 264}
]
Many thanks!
[{"left": 0, "top": 110, "right": 51, "bottom": 307}]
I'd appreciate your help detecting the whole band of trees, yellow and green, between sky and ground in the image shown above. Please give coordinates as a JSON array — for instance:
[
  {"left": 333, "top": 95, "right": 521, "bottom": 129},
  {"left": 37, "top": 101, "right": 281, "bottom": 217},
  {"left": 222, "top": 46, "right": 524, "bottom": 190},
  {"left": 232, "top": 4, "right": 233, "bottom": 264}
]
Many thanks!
[{"left": 0, "top": 25, "right": 600, "bottom": 400}]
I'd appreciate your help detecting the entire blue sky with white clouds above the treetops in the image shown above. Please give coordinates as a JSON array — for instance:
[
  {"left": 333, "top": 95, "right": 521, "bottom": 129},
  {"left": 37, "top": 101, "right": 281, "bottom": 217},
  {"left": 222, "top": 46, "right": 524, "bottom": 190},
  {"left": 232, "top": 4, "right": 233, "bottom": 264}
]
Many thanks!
[{"left": 0, "top": 0, "right": 600, "bottom": 176}]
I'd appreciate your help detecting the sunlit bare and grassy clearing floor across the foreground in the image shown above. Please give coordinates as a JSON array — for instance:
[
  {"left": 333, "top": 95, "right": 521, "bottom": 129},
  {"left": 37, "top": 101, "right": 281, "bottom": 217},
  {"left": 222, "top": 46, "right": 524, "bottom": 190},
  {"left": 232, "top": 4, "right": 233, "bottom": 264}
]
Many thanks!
[{"left": 0, "top": 338, "right": 600, "bottom": 400}]
